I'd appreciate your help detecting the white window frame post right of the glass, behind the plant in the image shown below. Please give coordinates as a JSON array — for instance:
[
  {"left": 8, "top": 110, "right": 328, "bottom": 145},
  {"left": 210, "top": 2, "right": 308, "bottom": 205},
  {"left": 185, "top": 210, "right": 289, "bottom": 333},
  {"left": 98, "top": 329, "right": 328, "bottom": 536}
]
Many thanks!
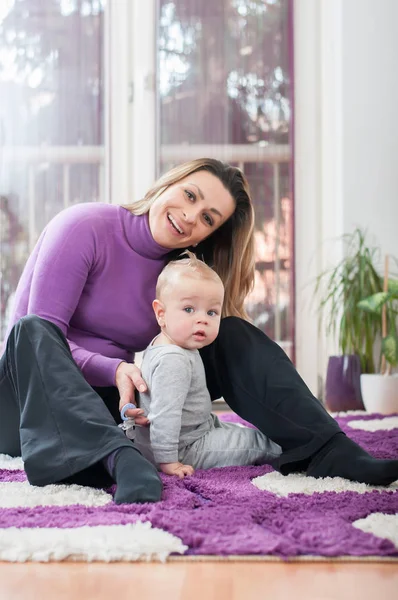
[{"left": 294, "top": 0, "right": 343, "bottom": 396}]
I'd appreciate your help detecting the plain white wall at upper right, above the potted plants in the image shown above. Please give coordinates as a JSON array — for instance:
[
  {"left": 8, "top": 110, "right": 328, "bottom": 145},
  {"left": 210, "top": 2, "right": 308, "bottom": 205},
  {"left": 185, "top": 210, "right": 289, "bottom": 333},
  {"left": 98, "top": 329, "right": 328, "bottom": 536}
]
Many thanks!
[{"left": 342, "top": 0, "right": 398, "bottom": 257}]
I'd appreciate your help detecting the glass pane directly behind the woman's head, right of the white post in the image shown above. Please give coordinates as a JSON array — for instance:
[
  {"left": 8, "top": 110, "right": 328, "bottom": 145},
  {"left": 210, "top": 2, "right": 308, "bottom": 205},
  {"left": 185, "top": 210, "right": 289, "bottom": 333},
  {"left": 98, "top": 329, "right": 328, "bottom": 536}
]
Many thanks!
[{"left": 157, "top": 0, "right": 294, "bottom": 357}]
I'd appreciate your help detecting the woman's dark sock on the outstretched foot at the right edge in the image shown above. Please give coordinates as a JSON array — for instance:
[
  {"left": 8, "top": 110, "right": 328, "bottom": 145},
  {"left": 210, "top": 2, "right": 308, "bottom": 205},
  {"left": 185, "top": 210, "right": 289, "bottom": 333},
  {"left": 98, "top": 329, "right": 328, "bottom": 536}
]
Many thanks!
[{"left": 307, "top": 433, "right": 398, "bottom": 485}]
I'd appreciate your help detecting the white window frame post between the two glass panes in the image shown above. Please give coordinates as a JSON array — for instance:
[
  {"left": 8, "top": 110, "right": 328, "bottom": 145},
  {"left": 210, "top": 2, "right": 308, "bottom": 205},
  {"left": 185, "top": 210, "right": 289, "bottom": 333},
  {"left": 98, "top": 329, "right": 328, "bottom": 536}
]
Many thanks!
[{"left": 105, "top": 0, "right": 157, "bottom": 204}]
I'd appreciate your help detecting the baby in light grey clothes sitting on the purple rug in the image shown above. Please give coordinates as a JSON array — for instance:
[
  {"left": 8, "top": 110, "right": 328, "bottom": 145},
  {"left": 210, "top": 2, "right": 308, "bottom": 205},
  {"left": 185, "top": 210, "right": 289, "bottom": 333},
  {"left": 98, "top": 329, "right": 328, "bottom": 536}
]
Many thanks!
[{"left": 135, "top": 252, "right": 281, "bottom": 478}]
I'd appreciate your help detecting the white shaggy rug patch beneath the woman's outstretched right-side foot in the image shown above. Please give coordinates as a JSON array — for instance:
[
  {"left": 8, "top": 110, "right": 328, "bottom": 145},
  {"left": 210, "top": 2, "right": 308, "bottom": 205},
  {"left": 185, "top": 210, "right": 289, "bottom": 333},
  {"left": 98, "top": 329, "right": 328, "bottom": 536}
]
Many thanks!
[{"left": 252, "top": 471, "right": 398, "bottom": 498}]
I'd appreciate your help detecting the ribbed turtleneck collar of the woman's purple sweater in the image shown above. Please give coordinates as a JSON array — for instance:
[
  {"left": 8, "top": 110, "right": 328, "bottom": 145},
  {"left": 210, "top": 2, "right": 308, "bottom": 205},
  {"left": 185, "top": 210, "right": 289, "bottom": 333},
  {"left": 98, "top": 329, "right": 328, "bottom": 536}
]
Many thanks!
[{"left": 119, "top": 206, "right": 171, "bottom": 259}]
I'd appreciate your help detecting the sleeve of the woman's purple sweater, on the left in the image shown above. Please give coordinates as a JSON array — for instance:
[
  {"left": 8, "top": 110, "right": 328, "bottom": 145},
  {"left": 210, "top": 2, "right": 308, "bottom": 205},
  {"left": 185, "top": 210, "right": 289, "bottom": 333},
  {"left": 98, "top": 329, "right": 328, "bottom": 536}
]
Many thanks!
[{"left": 27, "top": 206, "right": 121, "bottom": 386}]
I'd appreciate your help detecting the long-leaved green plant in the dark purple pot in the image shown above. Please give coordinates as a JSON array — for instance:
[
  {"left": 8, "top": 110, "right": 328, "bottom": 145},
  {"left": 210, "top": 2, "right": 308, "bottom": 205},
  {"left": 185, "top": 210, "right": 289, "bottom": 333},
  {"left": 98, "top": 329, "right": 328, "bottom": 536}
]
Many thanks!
[{"left": 315, "top": 229, "right": 383, "bottom": 411}]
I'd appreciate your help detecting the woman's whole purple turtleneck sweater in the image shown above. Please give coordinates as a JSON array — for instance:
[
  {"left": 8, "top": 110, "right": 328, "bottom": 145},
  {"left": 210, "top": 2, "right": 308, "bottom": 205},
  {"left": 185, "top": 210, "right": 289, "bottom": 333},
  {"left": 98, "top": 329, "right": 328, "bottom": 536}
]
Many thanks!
[{"left": 7, "top": 203, "right": 169, "bottom": 386}]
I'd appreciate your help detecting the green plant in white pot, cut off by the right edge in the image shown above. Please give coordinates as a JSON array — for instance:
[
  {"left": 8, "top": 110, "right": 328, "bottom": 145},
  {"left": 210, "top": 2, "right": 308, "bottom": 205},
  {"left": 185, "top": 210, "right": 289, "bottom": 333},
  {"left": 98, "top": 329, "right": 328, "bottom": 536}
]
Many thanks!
[{"left": 358, "top": 256, "right": 398, "bottom": 414}]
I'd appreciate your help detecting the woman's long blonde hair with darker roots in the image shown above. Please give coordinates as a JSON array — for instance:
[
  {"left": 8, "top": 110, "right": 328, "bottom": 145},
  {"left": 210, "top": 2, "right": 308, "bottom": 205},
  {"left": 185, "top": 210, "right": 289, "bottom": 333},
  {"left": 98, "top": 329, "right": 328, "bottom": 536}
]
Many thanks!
[{"left": 124, "top": 158, "right": 254, "bottom": 319}]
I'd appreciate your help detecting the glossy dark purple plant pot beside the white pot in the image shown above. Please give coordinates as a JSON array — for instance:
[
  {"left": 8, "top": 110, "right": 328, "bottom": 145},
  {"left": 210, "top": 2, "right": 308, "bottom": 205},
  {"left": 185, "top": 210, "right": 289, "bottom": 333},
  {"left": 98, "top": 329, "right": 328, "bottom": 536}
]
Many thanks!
[{"left": 325, "top": 354, "right": 365, "bottom": 412}]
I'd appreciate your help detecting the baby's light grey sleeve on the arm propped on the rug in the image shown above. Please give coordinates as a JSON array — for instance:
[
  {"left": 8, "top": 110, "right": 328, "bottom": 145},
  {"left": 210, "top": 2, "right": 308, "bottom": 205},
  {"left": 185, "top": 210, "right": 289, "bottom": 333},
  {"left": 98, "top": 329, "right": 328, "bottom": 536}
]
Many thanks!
[{"left": 148, "top": 351, "right": 192, "bottom": 463}]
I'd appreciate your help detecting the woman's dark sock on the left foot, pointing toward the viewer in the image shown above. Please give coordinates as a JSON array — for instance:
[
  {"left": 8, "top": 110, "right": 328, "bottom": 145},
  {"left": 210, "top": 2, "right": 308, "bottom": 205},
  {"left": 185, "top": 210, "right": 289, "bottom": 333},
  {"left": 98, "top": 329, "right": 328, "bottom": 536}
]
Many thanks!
[{"left": 102, "top": 446, "right": 162, "bottom": 504}]
